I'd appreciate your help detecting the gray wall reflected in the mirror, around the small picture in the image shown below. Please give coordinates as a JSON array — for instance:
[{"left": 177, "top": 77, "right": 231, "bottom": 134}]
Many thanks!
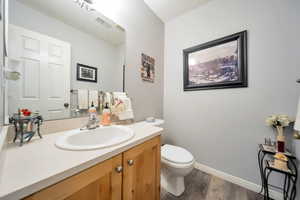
[{"left": 9, "top": 0, "right": 125, "bottom": 91}]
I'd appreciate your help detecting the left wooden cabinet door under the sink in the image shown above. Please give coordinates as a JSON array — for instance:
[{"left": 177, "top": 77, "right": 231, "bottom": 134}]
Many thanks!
[{"left": 25, "top": 155, "right": 122, "bottom": 200}]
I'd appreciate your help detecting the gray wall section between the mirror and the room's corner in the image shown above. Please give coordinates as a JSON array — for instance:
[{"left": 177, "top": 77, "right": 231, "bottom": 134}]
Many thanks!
[{"left": 99, "top": 0, "right": 164, "bottom": 120}]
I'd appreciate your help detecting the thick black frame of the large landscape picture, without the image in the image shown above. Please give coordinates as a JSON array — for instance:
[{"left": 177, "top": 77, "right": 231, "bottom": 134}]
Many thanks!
[{"left": 183, "top": 30, "right": 248, "bottom": 91}]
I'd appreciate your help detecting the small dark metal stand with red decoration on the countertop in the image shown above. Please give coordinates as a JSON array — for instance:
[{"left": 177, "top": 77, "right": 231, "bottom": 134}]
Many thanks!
[{"left": 9, "top": 109, "right": 43, "bottom": 146}]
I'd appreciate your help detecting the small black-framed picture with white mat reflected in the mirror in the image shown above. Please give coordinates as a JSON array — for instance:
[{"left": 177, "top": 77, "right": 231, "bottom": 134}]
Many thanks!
[{"left": 76, "top": 63, "right": 98, "bottom": 83}]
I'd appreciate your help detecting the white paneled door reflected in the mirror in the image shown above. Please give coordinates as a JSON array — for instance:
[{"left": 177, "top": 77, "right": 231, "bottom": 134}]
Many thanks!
[{"left": 8, "top": 25, "right": 71, "bottom": 119}]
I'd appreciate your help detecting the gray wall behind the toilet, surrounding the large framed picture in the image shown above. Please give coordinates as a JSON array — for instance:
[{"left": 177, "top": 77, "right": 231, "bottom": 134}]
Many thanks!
[{"left": 164, "top": 0, "right": 300, "bottom": 191}]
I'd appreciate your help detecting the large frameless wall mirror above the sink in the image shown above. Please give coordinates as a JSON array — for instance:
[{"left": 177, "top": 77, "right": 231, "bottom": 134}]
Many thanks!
[{"left": 7, "top": 0, "right": 126, "bottom": 120}]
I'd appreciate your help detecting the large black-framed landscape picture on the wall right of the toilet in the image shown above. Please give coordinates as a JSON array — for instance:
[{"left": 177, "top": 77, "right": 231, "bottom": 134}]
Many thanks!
[{"left": 183, "top": 31, "right": 248, "bottom": 91}]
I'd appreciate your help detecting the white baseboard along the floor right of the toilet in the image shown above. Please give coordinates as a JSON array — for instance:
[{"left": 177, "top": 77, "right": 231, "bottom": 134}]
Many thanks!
[{"left": 194, "top": 162, "right": 283, "bottom": 200}]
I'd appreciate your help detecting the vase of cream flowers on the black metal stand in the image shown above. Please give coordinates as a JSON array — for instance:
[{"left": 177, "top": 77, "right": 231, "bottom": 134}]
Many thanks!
[{"left": 266, "top": 115, "right": 292, "bottom": 152}]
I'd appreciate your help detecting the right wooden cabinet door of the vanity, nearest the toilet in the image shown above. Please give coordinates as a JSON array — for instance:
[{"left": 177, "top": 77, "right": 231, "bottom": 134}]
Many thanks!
[{"left": 123, "top": 136, "right": 160, "bottom": 200}]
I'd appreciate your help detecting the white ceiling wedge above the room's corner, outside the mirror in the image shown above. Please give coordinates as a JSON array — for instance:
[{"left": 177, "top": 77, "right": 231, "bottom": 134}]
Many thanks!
[{"left": 144, "top": 0, "right": 209, "bottom": 22}]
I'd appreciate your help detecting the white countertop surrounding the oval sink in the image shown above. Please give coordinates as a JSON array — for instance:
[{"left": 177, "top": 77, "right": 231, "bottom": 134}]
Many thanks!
[{"left": 0, "top": 122, "right": 163, "bottom": 200}]
